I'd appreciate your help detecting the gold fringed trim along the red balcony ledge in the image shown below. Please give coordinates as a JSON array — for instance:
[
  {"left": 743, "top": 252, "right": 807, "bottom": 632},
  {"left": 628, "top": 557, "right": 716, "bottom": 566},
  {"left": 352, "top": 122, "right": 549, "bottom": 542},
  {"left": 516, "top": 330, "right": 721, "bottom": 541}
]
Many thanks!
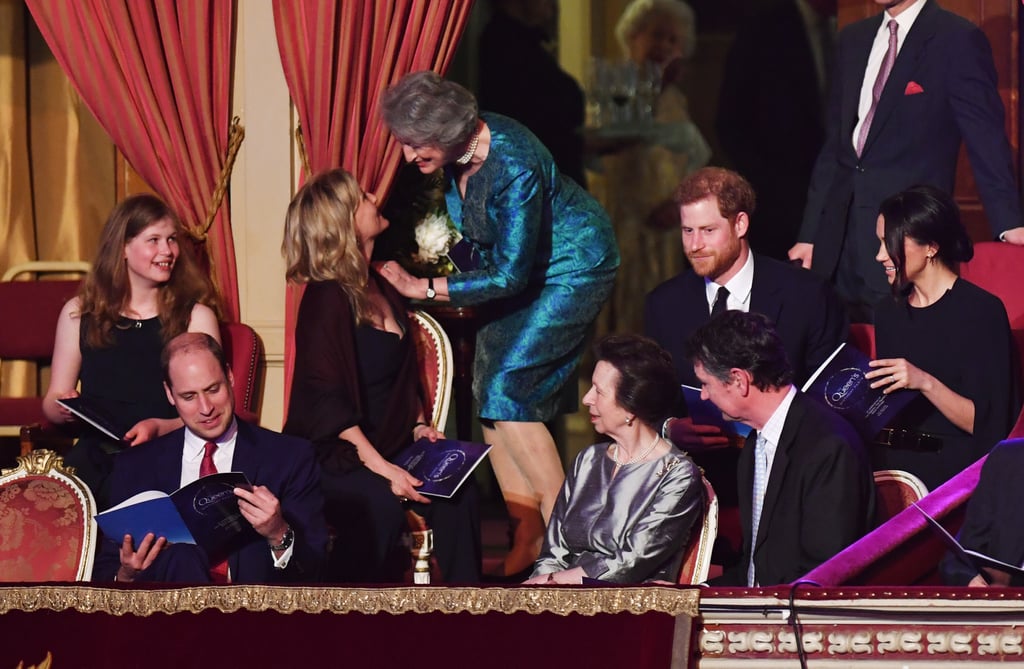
[{"left": 0, "top": 585, "right": 700, "bottom": 618}]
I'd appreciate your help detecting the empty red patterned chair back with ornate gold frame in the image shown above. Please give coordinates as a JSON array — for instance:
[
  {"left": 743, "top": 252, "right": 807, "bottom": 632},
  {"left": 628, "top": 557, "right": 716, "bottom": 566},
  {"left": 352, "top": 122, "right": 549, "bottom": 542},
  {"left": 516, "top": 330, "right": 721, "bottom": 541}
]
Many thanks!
[{"left": 0, "top": 449, "right": 97, "bottom": 583}]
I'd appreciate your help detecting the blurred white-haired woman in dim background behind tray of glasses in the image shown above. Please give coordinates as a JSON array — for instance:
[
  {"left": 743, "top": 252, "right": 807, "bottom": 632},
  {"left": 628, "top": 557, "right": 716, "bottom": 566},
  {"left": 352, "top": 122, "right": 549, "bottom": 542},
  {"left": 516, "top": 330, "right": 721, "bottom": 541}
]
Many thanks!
[{"left": 593, "top": 0, "right": 711, "bottom": 332}]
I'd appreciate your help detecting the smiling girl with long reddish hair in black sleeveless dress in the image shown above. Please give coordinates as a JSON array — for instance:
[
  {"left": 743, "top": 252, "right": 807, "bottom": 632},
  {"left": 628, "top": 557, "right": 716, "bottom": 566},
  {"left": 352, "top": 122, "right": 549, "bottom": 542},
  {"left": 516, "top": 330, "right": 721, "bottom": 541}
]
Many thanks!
[{"left": 43, "top": 195, "right": 220, "bottom": 508}]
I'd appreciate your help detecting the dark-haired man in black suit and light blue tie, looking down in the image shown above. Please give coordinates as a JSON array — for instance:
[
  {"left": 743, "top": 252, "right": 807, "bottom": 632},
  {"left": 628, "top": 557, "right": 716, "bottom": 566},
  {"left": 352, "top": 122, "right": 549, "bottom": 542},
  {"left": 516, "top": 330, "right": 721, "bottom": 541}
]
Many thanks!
[{"left": 686, "top": 311, "right": 874, "bottom": 587}]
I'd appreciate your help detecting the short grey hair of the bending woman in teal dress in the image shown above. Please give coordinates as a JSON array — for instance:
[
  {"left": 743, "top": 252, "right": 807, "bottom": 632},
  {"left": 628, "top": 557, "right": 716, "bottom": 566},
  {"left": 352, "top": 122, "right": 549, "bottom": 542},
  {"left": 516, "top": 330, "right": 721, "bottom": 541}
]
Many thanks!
[{"left": 381, "top": 71, "right": 479, "bottom": 155}]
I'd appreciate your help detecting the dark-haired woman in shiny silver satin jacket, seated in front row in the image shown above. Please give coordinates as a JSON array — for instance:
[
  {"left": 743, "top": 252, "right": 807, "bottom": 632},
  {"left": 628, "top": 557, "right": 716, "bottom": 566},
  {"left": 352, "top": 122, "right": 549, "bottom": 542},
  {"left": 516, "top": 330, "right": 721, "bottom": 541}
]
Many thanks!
[{"left": 526, "top": 335, "right": 703, "bottom": 585}]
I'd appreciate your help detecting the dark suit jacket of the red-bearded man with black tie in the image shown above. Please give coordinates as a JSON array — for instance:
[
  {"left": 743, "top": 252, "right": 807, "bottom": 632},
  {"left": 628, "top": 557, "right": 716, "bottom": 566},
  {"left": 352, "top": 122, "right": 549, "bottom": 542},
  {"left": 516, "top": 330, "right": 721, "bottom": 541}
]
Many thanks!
[{"left": 644, "top": 253, "right": 848, "bottom": 391}]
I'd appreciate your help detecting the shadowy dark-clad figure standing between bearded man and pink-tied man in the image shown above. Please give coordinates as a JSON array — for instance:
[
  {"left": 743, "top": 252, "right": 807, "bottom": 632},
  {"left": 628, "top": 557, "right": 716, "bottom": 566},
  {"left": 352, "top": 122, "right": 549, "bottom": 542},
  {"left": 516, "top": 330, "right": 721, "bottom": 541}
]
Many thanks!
[{"left": 717, "top": 0, "right": 836, "bottom": 260}]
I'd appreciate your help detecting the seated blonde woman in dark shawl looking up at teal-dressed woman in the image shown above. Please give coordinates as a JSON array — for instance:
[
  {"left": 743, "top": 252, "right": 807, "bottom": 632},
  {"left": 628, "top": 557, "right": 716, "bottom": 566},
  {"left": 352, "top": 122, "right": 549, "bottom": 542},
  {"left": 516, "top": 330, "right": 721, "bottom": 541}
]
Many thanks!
[{"left": 282, "top": 169, "right": 480, "bottom": 583}]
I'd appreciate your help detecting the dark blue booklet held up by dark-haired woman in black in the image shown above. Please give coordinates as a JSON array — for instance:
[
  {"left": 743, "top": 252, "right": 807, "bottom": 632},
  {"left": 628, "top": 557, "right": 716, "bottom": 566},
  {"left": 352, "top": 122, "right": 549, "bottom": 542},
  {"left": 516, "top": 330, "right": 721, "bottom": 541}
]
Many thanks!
[{"left": 803, "top": 343, "right": 919, "bottom": 442}]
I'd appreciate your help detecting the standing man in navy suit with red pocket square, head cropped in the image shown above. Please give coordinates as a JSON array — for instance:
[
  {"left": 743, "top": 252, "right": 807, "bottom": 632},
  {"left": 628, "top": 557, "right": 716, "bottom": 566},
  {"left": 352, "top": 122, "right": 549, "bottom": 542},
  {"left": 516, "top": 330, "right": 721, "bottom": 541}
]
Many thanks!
[{"left": 790, "top": 0, "right": 1024, "bottom": 321}]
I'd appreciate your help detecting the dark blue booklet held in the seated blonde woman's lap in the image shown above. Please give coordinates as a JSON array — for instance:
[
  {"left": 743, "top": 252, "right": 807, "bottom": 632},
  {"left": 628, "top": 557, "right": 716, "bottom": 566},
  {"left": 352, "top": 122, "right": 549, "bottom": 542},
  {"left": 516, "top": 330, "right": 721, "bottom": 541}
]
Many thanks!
[{"left": 391, "top": 438, "right": 490, "bottom": 498}]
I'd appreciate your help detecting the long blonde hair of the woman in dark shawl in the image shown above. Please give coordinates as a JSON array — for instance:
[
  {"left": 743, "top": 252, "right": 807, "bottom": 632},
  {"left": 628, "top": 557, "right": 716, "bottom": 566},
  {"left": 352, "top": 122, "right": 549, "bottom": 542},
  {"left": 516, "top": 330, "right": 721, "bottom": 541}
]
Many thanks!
[{"left": 281, "top": 168, "right": 374, "bottom": 324}]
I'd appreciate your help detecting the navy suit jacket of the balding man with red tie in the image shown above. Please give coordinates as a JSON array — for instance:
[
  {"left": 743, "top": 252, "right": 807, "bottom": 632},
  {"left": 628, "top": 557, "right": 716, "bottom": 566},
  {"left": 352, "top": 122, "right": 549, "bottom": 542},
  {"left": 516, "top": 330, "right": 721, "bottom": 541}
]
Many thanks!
[{"left": 92, "top": 417, "right": 327, "bottom": 583}]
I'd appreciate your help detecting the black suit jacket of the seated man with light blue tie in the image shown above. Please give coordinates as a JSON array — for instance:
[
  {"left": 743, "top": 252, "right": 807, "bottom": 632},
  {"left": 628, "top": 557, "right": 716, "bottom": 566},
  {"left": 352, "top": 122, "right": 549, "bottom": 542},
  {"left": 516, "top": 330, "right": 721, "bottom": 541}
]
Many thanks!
[{"left": 721, "top": 392, "right": 874, "bottom": 586}]
